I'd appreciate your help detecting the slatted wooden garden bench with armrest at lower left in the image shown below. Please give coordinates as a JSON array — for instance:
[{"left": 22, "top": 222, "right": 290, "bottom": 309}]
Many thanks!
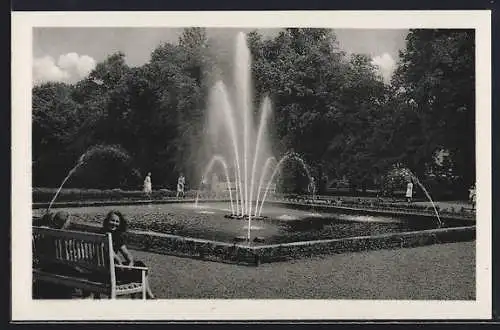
[{"left": 32, "top": 227, "right": 147, "bottom": 299}]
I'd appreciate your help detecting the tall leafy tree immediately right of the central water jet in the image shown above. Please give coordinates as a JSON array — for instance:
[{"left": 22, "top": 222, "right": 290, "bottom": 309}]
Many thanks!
[{"left": 249, "top": 29, "right": 350, "bottom": 183}]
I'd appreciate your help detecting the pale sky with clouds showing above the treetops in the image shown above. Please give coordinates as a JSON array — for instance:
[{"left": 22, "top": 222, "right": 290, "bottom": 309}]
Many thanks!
[{"left": 33, "top": 27, "right": 408, "bottom": 84}]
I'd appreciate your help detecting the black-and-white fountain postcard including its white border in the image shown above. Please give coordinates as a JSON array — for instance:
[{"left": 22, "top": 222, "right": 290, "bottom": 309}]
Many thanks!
[{"left": 12, "top": 11, "right": 491, "bottom": 319}]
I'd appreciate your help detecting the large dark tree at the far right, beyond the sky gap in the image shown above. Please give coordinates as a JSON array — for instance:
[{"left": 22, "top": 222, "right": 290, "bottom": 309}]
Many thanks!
[{"left": 393, "top": 29, "right": 475, "bottom": 195}]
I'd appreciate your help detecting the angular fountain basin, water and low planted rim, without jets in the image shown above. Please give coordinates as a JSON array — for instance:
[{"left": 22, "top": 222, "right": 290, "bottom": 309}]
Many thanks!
[{"left": 33, "top": 203, "right": 475, "bottom": 264}]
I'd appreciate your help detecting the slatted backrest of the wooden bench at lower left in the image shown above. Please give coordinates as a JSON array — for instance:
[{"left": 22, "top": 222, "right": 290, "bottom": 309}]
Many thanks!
[{"left": 32, "top": 227, "right": 114, "bottom": 275}]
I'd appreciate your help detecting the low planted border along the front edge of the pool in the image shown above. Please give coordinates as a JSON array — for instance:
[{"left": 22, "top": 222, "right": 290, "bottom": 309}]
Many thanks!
[{"left": 67, "top": 219, "right": 476, "bottom": 265}]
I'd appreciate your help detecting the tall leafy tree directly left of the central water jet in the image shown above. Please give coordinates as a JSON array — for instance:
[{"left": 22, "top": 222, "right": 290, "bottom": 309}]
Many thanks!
[{"left": 146, "top": 28, "right": 213, "bottom": 185}]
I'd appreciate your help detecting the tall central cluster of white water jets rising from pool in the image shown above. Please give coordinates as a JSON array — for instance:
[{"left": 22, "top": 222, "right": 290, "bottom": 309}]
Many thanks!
[{"left": 202, "top": 33, "right": 311, "bottom": 241}]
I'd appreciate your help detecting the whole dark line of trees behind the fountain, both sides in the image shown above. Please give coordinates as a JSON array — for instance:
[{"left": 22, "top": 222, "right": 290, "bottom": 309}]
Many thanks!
[{"left": 32, "top": 28, "right": 475, "bottom": 199}]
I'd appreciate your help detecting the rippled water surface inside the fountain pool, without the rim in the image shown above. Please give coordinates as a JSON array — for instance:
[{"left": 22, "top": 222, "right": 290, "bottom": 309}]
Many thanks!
[{"left": 33, "top": 203, "right": 464, "bottom": 245}]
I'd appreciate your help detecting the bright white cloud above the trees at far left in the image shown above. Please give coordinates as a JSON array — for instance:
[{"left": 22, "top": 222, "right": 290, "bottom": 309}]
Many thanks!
[{"left": 33, "top": 53, "right": 96, "bottom": 84}]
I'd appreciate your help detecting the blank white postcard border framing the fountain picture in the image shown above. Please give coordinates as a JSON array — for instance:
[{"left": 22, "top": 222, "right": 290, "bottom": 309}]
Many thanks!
[{"left": 11, "top": 10, "right": 492, "bottom": 321}]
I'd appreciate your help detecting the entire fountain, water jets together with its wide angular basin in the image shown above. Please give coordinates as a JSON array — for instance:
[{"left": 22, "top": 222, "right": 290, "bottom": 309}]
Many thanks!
[{"left": 32, "top": 34, "right": 475, "bottom": 270}]
